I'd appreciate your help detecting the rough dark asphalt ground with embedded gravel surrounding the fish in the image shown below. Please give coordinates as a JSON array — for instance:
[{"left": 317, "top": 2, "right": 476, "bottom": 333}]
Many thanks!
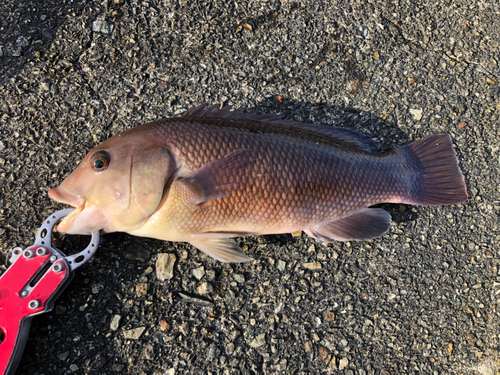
[{"left": 0, "top": 0, "right": 500, "bottom": 374}]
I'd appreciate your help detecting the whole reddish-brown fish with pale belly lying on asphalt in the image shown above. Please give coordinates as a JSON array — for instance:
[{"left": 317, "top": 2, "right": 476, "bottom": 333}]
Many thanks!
[{"left": 48, "top": 104, "right": 468, "bottom": 262}]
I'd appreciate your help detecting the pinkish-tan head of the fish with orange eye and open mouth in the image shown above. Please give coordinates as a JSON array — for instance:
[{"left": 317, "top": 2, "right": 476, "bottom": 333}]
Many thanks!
[{"left": 48, "top": 129, "right": 176, "bottom": 234}]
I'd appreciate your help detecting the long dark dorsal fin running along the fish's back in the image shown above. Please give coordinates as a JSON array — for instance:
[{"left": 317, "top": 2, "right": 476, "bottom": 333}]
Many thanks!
[{"left": 182, "top": 104, "right": 380, "bottom": 153}]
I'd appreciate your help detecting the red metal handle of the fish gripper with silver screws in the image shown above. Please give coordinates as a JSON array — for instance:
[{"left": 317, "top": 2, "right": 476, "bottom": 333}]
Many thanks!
[{"left": 0, "top": 246, "right": 73, "bottom": 374}]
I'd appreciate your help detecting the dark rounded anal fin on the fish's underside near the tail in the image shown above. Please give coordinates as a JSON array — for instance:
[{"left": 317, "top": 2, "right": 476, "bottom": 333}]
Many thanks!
[{"left": 305, "top": 208, "right": 391, "bottom": 242}]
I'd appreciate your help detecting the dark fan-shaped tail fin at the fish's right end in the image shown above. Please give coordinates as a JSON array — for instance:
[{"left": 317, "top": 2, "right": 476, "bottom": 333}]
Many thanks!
[{"left": 396, "top": 134, "right": 467, "bottom": 206}]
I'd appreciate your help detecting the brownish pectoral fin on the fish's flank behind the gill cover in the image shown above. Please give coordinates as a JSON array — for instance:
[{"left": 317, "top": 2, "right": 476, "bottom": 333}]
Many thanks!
[{"left": 180, "top": 149, "right": 254, "bottom": 204}]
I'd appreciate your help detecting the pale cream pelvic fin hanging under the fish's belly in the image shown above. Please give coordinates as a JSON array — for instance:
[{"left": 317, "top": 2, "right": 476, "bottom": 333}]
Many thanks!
[{"left": 190, "top": 238, "right": 253, "bottom": 263}]
